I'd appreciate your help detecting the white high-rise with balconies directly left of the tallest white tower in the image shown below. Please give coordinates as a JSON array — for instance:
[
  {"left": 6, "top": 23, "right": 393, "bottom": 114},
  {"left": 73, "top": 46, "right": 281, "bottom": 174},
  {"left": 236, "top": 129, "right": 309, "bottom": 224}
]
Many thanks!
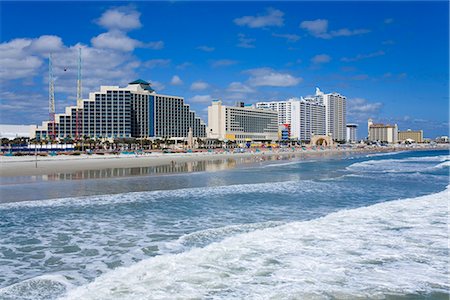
[{"left": 291, "top": 98, "right": 326, "bottom": 141}]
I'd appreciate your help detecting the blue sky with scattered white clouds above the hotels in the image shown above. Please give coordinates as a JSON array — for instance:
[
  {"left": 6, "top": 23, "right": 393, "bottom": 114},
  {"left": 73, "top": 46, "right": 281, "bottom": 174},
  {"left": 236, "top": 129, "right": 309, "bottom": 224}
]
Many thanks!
[{"left": 0, "top": 1, "right": 449, "bottom": 138}]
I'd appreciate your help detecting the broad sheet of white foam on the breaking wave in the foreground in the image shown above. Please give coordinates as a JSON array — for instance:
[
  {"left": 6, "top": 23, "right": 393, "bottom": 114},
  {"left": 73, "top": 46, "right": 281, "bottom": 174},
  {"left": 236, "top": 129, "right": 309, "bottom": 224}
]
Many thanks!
[{"left": 65, "top": 187, "right": 450, "bottom": 299}]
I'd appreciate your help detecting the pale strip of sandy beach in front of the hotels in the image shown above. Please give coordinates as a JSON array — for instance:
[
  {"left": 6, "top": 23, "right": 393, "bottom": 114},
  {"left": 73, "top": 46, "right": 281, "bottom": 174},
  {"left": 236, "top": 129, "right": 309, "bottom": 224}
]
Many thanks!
[{"left": 0, "top": 145, "right": 449, "bottom": 179}]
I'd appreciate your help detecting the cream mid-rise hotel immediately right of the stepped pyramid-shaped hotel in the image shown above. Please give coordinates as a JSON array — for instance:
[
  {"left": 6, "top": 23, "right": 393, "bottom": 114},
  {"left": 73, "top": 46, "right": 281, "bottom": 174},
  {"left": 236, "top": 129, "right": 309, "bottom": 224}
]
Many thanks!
[{"left": 208, "top": 100, "right": 278, "bottom": 143}]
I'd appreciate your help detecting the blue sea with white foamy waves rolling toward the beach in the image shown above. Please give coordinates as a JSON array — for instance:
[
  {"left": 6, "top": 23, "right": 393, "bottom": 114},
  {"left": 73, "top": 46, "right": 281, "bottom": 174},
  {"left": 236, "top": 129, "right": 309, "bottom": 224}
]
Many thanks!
[{"left": 0, "top": 151, "right": 450, "bottom": 299}]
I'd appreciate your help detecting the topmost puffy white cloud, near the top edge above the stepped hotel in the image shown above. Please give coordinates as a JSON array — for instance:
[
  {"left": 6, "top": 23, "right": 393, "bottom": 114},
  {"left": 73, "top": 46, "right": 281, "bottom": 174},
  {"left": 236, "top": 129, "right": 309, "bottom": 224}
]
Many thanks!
[{"left": 97, "top": 6, "right": 142, "bottom": 31}]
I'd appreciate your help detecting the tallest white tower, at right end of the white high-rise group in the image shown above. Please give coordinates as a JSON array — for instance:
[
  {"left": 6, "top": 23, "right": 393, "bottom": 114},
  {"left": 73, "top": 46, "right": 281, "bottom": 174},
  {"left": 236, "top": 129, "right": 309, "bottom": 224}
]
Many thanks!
[{"left": 316, "top": 88, "right": 347, "bottom": 141}]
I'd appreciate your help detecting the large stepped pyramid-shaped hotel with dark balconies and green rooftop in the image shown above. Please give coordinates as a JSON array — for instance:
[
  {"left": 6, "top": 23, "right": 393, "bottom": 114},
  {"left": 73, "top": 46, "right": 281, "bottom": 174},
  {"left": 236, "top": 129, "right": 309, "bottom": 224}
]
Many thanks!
[{"left": 31, "top": 80, "right": 206, "bottom": 140}]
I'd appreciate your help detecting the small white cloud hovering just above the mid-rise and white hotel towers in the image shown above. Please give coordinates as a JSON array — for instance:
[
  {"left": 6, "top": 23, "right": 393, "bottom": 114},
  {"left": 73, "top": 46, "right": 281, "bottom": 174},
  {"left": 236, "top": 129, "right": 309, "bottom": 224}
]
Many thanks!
[{"left": 246, "top": 68, "right": 303, "bottom": 87}]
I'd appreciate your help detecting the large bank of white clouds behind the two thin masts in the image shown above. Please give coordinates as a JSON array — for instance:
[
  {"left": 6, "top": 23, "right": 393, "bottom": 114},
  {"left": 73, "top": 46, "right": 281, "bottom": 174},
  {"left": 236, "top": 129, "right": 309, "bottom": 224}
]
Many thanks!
[{"left": 0, "top": 7, "right": 160, "bottom": 122}]
